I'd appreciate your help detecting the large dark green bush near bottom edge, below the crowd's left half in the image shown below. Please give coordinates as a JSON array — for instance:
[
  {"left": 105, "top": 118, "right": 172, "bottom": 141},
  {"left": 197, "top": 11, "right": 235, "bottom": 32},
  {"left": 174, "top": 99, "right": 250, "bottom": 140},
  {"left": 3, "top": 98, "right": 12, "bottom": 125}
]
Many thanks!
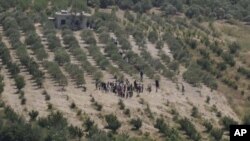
[{"left": 105, "top": 114, "right": 121, "bottom": 132}]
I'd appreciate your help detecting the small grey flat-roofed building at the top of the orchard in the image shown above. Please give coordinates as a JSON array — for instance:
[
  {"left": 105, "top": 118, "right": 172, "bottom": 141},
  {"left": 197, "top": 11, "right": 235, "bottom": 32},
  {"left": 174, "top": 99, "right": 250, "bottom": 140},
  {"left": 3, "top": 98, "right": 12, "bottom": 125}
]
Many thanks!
[{"left": 50, "top": 10, "right": 91, "bottom": 30}]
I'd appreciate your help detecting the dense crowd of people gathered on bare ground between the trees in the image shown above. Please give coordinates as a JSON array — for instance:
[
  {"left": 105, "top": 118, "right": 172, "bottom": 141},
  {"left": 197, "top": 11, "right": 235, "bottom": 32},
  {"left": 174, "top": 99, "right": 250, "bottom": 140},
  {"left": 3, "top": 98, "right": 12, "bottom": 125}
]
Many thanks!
[{"left": 95, "top": 76, "right": 159, "bottom": 98}]
